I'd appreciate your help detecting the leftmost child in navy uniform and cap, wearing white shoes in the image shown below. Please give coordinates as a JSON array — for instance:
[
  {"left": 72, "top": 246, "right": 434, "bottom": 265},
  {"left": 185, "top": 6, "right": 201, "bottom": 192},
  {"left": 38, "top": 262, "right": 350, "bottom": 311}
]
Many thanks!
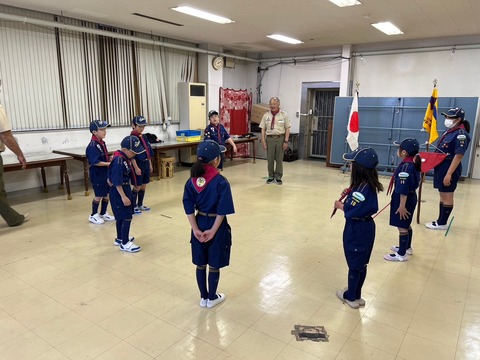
[{"left": 85, "top": 120, "right": 115, "bottom": 225}]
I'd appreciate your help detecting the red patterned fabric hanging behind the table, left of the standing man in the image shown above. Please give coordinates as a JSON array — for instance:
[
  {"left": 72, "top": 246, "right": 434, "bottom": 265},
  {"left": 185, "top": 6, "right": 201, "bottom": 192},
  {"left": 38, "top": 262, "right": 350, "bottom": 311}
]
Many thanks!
[{"left": 219, "top": 88, "right": 252, "bottom": 156}]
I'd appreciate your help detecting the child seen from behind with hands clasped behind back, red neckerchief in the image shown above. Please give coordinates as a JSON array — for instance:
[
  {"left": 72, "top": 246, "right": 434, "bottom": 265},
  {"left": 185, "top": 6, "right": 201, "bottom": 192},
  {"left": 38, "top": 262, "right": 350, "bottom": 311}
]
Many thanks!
[{"left": 183, "top": 140, "right": 235, "bottom": 308}]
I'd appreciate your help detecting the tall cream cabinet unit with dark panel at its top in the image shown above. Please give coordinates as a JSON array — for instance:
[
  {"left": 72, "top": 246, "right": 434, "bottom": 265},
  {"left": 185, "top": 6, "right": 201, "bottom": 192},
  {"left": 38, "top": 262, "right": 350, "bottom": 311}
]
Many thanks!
[{"left": 178, "top": 82, "right": 207, "bottom": 130}]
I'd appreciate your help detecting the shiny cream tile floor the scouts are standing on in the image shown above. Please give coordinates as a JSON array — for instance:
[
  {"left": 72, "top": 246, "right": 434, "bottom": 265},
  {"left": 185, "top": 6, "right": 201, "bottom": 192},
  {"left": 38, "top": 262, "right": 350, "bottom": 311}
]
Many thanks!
[{"left": 0, "top": 160, "right": 480, "bottom": 360}]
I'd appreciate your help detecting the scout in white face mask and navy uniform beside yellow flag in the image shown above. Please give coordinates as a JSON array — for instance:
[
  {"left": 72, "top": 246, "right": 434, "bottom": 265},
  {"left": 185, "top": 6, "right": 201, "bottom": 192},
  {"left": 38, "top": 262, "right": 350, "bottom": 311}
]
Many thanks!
[{"left": 425, "top": 108, "right": 470, "bottom": 230}]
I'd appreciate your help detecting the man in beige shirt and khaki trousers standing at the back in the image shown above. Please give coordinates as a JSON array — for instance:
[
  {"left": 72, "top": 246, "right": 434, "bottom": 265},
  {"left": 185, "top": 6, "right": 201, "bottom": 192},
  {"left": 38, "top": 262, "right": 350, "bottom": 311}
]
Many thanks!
[{"left": 259, "top": 97, "right": 290, "bottom": 185}]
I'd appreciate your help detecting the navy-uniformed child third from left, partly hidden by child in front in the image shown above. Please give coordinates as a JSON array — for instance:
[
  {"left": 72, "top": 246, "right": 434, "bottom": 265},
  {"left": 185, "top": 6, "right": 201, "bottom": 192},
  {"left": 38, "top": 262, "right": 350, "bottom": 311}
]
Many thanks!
[{"left": 130, "top": 116, "right": 153, "bottom": 214}]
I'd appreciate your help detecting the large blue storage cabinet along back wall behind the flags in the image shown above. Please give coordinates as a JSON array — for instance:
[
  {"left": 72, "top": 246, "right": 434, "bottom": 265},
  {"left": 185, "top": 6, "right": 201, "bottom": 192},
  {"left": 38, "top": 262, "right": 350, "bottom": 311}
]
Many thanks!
[{"left": 330, "top": 97, "right": 478, "bottom": 176}]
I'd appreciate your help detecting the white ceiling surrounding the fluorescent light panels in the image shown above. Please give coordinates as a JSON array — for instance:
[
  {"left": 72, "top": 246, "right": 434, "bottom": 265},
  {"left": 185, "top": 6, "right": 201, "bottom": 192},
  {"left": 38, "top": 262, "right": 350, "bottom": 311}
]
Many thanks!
[{"left": 1, "top": 0, "right": 480, "bottom": 56}]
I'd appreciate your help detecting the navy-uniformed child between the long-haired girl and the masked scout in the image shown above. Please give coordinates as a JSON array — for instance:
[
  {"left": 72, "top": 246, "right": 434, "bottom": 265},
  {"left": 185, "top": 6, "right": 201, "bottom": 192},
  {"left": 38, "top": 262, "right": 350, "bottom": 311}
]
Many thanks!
[{"left": 383, "top": 138, "right": 422, "bottom": 261}]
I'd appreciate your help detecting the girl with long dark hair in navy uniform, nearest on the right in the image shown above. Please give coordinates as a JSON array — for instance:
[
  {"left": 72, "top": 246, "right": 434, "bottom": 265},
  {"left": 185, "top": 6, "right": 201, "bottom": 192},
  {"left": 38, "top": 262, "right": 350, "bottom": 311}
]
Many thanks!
[{"left": 334, "top": 148, "right": 383, "bottom": 309}]
